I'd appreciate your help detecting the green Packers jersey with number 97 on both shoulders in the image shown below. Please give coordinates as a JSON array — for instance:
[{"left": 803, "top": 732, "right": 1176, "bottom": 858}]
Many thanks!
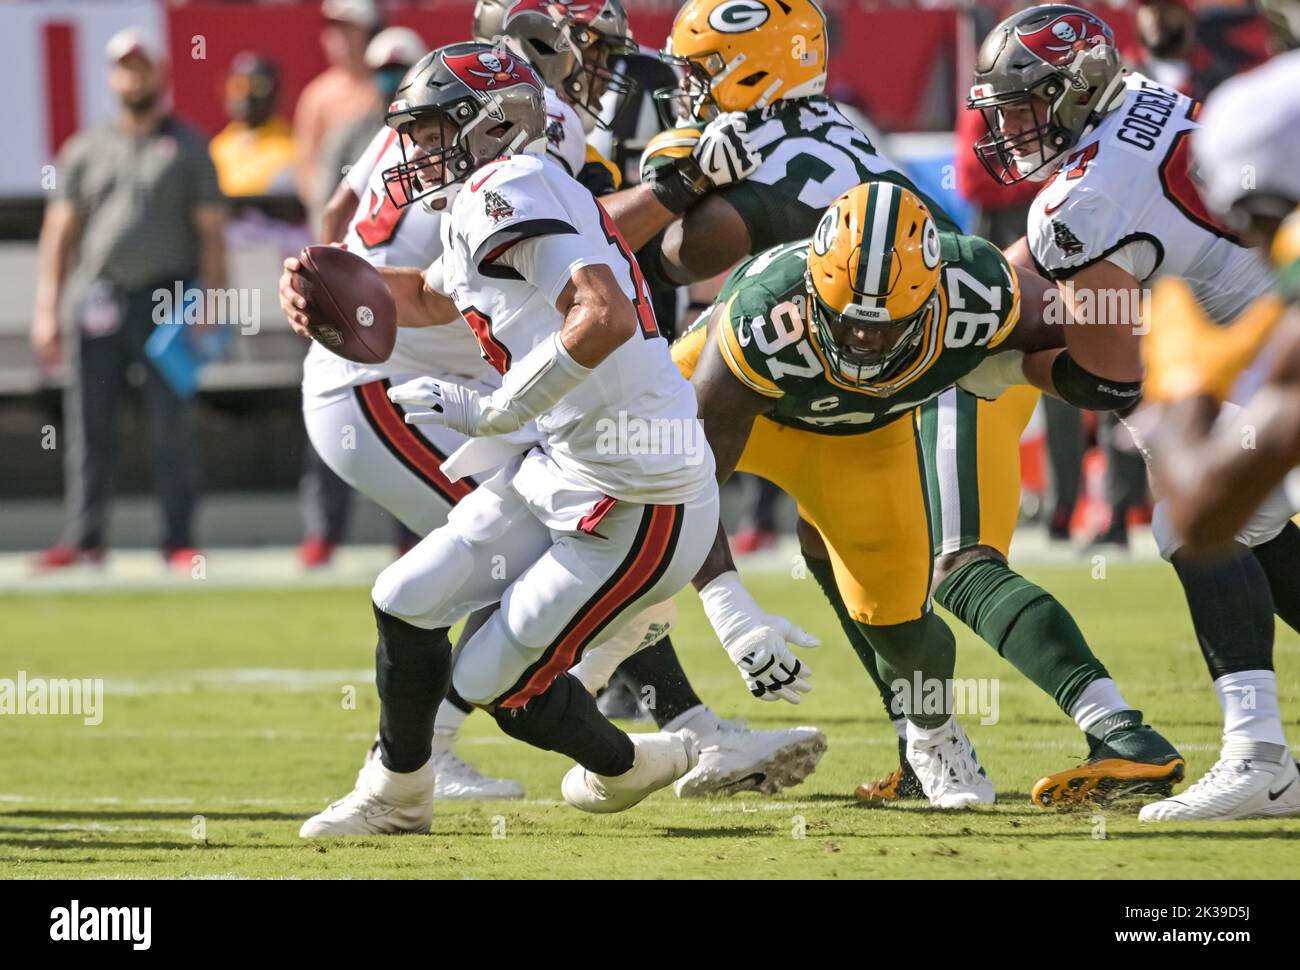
[{"left": 683, "top": 233, "right": 1021, "bottom": 434}]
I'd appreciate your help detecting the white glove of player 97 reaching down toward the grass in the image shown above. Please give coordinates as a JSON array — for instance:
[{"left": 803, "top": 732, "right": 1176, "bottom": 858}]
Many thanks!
[{"left": 699, "top": 571, "right": 820, "bottom": 703}]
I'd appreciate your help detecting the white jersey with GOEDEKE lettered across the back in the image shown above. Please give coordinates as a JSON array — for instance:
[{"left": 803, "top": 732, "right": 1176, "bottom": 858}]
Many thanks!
[{"left": 1028, "top": 74, "right": 1270, "bottom": 322}]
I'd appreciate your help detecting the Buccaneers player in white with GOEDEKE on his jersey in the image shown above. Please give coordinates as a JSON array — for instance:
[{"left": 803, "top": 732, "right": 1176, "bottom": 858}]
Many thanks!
[{"left": 969, "top": 4, "right": 1300, "bottom": 819}]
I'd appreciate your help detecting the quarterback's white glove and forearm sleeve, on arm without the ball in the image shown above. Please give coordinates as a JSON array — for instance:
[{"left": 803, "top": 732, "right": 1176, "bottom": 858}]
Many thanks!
[{"left": 389, "top": 333, "right": 593, "bottom": 437}]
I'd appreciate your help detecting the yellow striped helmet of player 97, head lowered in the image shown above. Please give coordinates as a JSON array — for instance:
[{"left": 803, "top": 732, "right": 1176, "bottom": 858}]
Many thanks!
[{"left": 806, "top": 182, "right": 943, "bottom": 386}]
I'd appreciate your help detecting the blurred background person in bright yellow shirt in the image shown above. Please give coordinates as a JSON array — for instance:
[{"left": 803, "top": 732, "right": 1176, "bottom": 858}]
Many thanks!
[{"left": 209, "top": 51, "right": 294, "bottom": 195}]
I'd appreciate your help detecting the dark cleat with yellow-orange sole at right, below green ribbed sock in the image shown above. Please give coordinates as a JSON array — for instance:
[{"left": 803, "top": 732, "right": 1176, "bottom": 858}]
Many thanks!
[{"left": 1030, "top": 711, "right": 1187, "bottom": 809}]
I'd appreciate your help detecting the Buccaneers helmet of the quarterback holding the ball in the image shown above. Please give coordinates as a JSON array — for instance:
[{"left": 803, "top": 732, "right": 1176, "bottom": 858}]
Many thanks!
[{"left": 384, "top": 43, "right": 546, "bottom": 212}]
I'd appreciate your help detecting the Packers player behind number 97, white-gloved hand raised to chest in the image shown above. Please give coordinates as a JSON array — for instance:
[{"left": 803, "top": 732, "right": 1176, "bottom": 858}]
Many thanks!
[{"left": 603, "top": 0, "right": 956, "bottom": 283}]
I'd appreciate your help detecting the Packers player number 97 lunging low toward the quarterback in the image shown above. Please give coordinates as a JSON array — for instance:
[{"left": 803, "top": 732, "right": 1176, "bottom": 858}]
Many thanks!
[{"left": 673, "top": 182, "right": 1183, "bottom": 807}]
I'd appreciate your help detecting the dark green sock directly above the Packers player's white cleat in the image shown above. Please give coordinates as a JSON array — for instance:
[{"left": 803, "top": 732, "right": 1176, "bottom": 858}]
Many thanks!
[{"left": 858, "top": 612, "right": 957, "bottom": 729}]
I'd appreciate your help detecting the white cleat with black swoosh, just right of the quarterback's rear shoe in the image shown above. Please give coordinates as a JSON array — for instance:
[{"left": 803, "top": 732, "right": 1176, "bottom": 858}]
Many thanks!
[{"left": 675, "top": 720, "right": 826, "bottom": 798}]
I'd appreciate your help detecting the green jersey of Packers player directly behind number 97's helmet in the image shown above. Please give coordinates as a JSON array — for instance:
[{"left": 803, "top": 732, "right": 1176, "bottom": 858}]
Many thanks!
[{"left": 718, "top": 96, "right": 957, "bottom": 252}]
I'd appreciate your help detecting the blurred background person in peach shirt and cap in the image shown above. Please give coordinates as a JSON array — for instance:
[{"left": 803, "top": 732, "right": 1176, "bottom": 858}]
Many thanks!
[{"left": 294, "top": 0, "right": 380, "bottom": 213}]
